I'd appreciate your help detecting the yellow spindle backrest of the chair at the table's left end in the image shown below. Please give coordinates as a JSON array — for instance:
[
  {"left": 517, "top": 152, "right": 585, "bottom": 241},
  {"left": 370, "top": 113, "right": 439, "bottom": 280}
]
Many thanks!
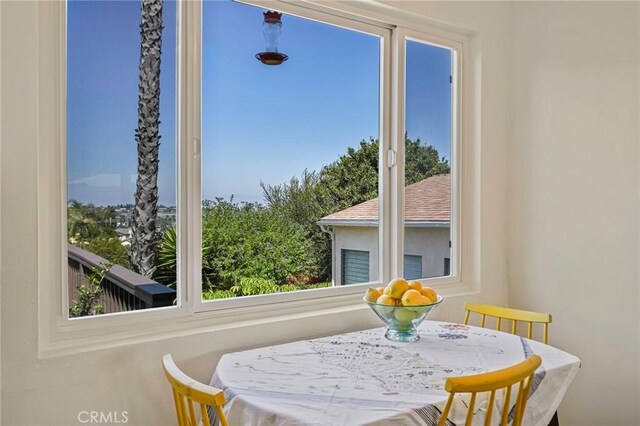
[{"left": 162, "top": 354, "right": 229, "bottom": 426}]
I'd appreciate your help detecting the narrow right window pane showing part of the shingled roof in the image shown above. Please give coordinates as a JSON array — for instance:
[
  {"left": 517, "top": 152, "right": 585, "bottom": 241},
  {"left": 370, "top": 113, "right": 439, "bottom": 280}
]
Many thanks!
[{"left": 404, "top": 38, "right": 455, "bottom": 279}]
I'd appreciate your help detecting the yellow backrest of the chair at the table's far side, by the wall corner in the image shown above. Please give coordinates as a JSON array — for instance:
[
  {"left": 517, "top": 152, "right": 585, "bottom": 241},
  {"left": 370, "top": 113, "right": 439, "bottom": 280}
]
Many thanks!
[{"left": 464, "top": 302, "right": 552, "bottom": 344}]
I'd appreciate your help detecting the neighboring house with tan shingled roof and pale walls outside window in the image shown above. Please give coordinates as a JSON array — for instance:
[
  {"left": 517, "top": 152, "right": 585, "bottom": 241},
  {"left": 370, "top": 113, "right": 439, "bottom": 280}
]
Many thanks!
[{"left": 318, "top": 174, "right": 451, "bottom": 285}]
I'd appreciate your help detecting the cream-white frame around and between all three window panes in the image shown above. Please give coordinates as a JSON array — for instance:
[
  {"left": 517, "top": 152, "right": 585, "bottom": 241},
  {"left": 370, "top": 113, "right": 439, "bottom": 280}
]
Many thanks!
[{"left": 37, "top": 0, "right": 479, "bottom": 357}]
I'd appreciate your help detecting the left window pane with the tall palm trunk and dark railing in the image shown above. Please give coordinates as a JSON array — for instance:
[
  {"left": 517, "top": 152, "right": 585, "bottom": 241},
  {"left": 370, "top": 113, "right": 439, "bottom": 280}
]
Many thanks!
[{"left": 65, "top": 1, "right": 178, "bottom": 317}]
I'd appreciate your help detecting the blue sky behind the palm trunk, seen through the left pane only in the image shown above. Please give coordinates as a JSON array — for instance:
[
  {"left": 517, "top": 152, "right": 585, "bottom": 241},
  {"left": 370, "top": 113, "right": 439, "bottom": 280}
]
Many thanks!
[{"left": 67, "top": 1, "right": 176, "bottom": 205}]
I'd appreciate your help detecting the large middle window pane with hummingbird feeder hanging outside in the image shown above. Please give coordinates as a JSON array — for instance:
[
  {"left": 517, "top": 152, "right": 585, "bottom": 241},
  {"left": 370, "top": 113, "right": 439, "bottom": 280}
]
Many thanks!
[{"left": 201, "top": 1, "right": 381, "bottom": 301}]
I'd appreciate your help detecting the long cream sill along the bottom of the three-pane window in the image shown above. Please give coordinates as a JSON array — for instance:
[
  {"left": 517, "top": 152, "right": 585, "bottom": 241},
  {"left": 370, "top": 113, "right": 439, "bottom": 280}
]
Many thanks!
[{"left": 38, "top": 283, "right": 476, "bottom": 359}]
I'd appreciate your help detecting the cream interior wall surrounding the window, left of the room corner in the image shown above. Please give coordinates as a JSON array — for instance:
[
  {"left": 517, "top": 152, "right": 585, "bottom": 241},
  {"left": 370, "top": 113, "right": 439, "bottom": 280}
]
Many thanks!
[{"left": 0, "top": 1, "right": 510, "bottom": 426}]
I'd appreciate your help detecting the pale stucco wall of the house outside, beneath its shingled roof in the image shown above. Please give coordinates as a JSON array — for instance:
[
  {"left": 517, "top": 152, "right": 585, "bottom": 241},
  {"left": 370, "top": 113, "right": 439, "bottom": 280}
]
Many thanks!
[{"left": 332, "top": 226, "right": 451, "bottom": 285}]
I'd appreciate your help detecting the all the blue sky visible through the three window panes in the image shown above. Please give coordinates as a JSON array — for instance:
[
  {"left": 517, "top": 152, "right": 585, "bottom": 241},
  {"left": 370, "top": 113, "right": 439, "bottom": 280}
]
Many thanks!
[{"left": 67, "top": 0, "right": 450, "bottom": 205}]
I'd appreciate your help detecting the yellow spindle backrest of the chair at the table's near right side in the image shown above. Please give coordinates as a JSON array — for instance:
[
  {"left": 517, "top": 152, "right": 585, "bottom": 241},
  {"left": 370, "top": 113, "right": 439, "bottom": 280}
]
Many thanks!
[{"left": 438, "top": 355, "right": 542, "bottom": 426}]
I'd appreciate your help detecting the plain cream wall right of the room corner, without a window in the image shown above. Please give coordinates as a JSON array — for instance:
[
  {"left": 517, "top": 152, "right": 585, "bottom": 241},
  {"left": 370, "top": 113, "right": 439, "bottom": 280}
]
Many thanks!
[{"left": 507, "top": 2, "right": 640, "bottom": 426}]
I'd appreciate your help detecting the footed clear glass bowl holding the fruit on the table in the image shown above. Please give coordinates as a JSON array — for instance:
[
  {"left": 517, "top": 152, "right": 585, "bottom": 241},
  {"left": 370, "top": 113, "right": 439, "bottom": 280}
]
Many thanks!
[{"left": 363, "top": 295, "right": 442, "bottom": 342}]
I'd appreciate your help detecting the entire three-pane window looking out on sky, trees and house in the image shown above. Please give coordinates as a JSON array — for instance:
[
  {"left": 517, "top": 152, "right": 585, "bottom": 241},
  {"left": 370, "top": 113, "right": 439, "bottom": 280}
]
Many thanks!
[{"left": 50, "top": 0, "right": 462, "bottom": 330}]
